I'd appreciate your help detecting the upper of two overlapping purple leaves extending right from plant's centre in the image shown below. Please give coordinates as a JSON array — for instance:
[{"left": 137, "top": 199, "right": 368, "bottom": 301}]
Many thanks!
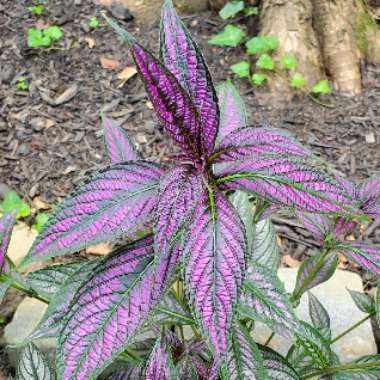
[{"left": 214, "top": 127, "right": 311, "bottom": 162}]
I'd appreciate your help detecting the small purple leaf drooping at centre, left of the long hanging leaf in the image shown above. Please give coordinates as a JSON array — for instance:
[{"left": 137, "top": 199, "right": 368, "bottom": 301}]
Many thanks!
[{"left": 154, "top": 166, "right": 202, "bottom": 254}]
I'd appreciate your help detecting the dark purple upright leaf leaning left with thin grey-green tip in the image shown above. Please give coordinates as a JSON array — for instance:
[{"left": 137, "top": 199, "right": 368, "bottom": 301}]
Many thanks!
[{"left": 107, "top": 19, "right": 202, "bottom": 158}]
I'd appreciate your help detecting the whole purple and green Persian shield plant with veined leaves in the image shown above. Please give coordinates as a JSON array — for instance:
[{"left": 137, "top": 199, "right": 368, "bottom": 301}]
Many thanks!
[{"left": 0, "top": 1, "right": 380, "bottom": 380}]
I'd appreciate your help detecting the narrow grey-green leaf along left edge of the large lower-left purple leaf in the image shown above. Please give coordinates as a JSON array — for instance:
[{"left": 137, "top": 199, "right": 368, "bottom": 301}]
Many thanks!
[{"left": 29, "top": 259, "right": 99, "bottom": 340}]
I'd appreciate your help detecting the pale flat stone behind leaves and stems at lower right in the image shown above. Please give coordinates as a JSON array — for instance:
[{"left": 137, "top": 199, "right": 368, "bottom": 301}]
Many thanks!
[{"left": 252, "top": 268, "right": 377, "bottom": 362}]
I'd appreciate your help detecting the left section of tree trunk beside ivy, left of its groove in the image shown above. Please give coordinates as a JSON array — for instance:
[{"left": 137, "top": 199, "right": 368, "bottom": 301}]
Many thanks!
[{"left": 259, "top": 0, "right": 324, "bottom": 102}]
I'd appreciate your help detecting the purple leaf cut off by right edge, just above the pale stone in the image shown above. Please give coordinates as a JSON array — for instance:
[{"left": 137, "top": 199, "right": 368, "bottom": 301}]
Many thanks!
[{"left": 339, "top": 240, "right": 380, "bottom": 276}]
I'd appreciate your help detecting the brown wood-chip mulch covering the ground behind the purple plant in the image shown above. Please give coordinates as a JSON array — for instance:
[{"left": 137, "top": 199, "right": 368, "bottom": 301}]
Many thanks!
[{"left": 0, "top": 0, "right": 380, "bottom": 378}]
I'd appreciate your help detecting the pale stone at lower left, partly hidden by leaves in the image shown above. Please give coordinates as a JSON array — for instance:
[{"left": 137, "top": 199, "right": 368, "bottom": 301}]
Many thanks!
[{"left": 3, "top": 297, "right": 56, "bottom": 366}]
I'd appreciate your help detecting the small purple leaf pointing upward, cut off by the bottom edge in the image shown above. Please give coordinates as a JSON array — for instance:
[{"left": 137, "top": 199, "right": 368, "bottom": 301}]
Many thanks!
[{"left": 145, "top": 337, "right": 174, "bottom": 380}]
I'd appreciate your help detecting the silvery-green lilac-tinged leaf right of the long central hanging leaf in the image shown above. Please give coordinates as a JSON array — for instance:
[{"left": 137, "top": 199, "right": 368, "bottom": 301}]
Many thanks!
[{"left": 239, "top": 261, "right": 298, "bottom": 338}]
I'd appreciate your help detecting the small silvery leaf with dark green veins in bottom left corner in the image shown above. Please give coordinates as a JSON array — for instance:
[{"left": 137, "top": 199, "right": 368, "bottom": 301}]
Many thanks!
[{"left": 16, "top": 343, "right": 54, "bottom": 380}]
